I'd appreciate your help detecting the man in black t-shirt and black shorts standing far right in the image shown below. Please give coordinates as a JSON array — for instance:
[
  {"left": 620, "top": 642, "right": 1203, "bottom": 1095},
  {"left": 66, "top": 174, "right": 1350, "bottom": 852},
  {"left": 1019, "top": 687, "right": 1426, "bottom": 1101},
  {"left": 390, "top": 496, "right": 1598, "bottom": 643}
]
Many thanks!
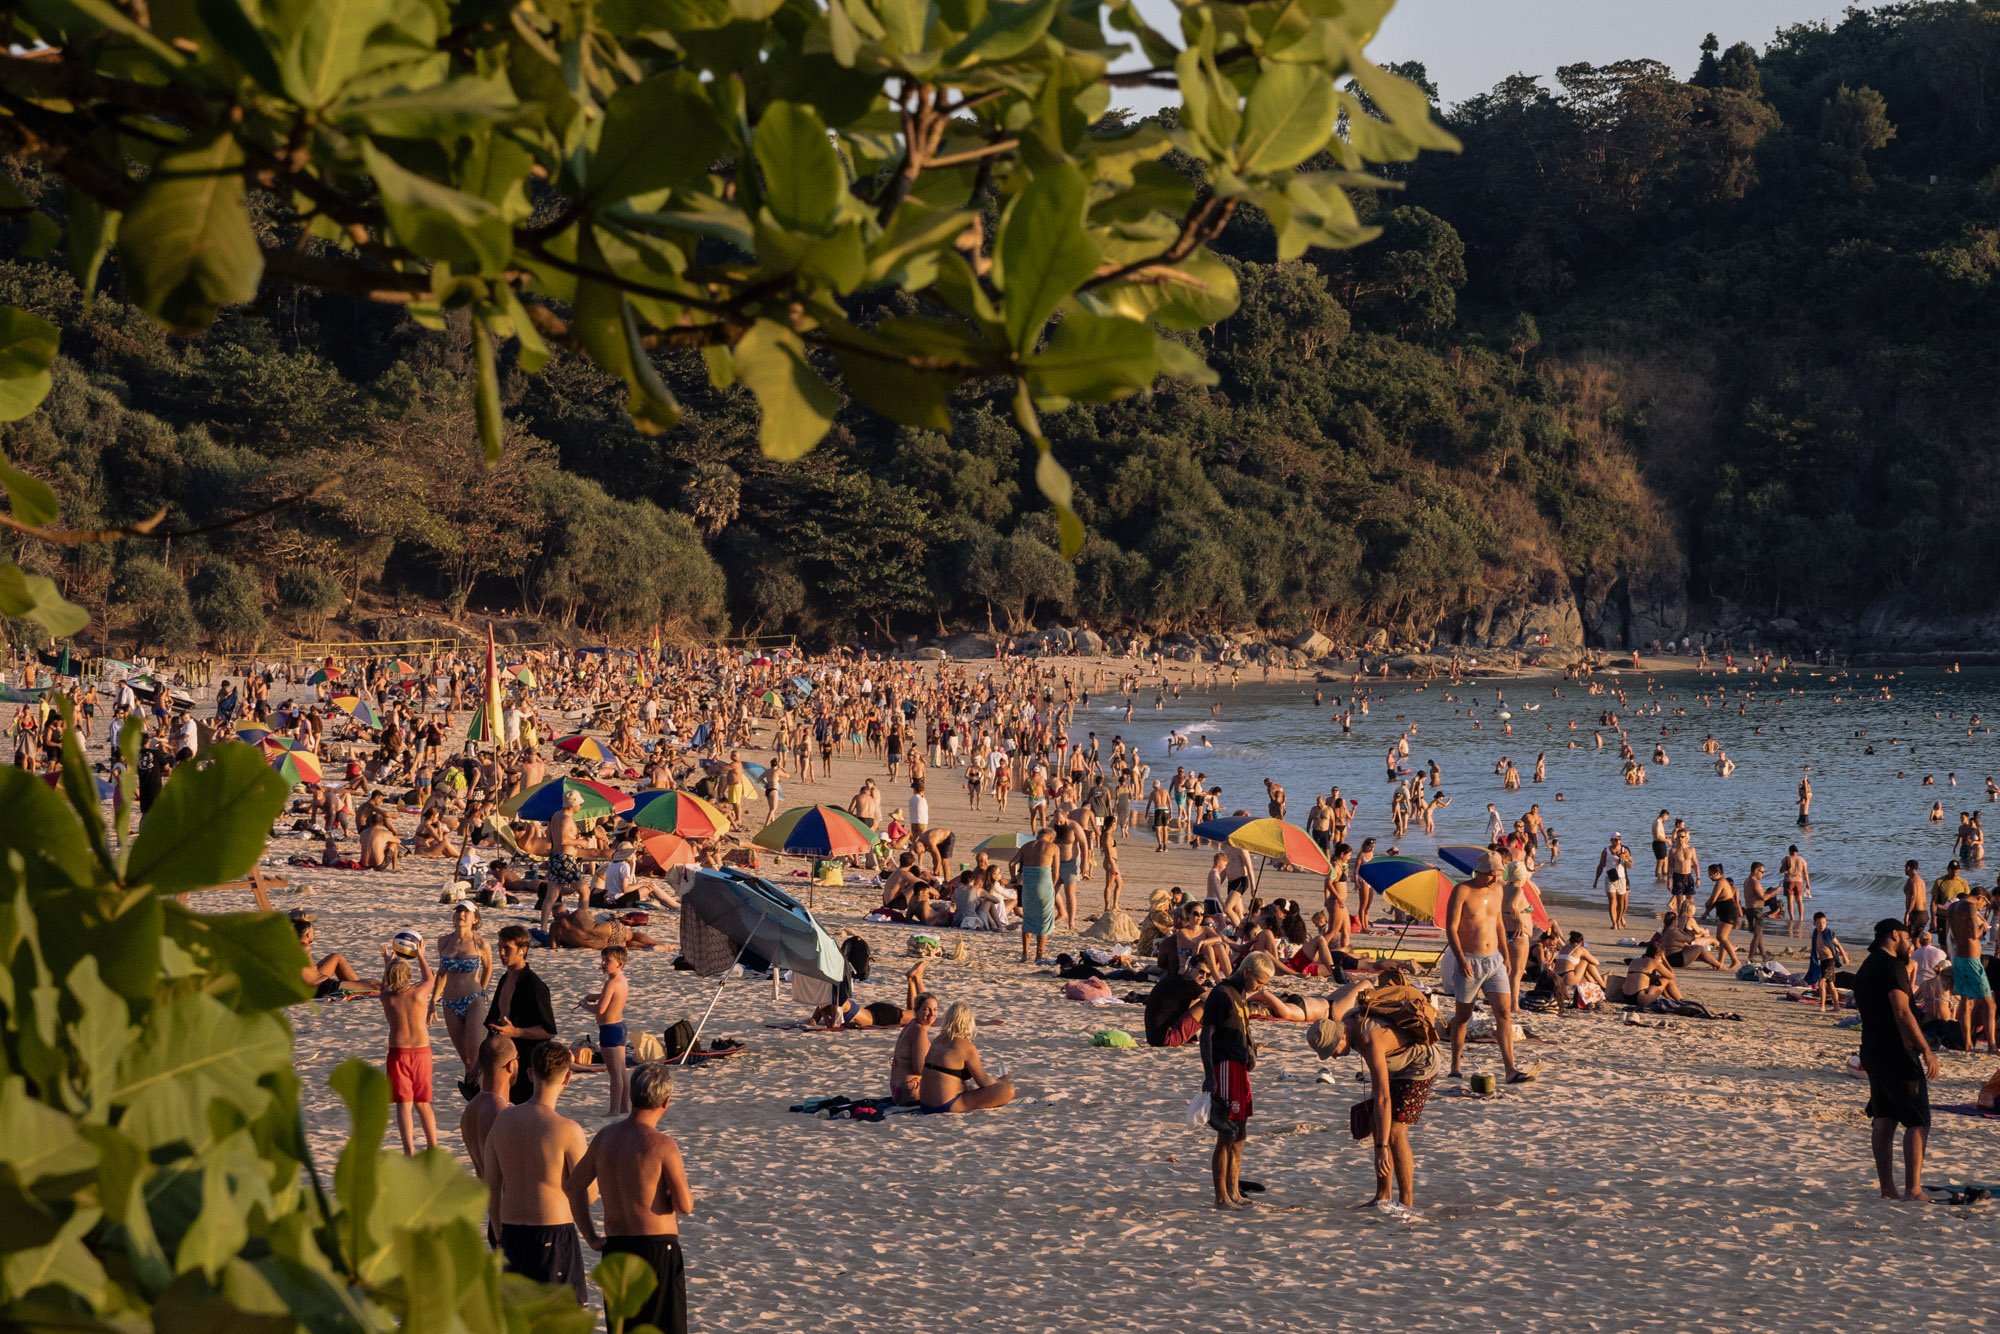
[{"left": 1854, "top": 918, "right": 1938, "bottom": 1200}]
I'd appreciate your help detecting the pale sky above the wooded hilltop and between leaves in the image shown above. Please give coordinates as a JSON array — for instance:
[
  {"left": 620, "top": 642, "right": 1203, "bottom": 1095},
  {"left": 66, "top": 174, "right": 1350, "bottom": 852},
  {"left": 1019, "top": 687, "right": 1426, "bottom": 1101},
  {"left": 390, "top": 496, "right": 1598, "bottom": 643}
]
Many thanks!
[{"left": 1114, "top": 0, "right": 1882, "bottom": 110}]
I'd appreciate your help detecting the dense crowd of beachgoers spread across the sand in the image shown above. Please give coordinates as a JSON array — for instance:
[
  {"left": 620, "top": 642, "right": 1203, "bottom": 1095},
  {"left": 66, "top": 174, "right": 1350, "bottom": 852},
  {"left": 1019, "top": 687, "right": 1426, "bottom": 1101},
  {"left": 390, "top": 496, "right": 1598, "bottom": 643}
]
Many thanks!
[{"left": 3, "top": 648, "right": 2000, "bottom": 1330}]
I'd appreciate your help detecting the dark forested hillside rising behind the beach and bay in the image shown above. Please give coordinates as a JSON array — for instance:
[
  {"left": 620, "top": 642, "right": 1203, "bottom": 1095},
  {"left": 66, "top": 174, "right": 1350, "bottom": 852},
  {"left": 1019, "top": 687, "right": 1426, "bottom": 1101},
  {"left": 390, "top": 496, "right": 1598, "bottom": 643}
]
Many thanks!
[{"left": 0, "top": 0, "right": 2000, "bottom": 646}]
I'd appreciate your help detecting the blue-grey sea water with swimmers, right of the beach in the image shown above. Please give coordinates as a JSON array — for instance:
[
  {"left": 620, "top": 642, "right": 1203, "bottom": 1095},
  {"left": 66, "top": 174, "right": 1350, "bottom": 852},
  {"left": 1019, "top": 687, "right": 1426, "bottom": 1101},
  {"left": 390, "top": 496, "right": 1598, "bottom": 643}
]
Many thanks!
[{"left": 1072, "top": 666, "right": 2000, "bottom": 932}]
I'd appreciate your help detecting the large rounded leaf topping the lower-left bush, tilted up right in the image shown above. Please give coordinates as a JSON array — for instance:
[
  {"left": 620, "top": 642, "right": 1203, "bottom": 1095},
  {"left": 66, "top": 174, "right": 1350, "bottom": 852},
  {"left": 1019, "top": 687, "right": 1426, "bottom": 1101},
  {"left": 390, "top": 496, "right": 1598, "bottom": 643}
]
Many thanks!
[{"left": 124, "top": 742, "right": 290, "bottom": 894}]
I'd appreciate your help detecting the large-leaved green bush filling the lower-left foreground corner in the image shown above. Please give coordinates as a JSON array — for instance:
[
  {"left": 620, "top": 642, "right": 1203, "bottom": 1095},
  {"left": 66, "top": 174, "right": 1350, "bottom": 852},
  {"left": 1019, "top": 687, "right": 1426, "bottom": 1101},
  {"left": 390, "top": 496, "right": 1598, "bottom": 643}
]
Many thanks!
[{"left": 0, "top": 708, "right": 596, "bottom": 1334}]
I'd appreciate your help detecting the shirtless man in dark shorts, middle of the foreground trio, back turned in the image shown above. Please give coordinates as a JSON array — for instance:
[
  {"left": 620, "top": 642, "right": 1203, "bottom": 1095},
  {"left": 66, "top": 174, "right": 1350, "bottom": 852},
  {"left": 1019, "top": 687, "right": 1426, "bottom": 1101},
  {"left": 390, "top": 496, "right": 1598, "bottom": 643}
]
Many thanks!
[{"left": 480, "top": 1042, "right": 588, "bottom": 1304}]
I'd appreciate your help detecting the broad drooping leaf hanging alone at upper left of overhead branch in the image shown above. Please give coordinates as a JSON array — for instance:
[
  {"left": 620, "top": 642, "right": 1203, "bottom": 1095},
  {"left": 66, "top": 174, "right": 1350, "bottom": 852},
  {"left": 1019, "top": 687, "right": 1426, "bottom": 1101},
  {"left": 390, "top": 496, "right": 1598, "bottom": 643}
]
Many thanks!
[{"left": 118, "top": 134, "right": 264, "bottom": 334}]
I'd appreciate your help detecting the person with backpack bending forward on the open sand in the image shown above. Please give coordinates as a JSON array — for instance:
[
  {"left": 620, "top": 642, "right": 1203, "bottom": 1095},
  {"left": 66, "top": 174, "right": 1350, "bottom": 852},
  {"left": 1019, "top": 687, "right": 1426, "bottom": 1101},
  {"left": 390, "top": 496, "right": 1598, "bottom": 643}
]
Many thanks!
[{"left": 1306, "top": 968, "right": 1438, "bottom": 1220}]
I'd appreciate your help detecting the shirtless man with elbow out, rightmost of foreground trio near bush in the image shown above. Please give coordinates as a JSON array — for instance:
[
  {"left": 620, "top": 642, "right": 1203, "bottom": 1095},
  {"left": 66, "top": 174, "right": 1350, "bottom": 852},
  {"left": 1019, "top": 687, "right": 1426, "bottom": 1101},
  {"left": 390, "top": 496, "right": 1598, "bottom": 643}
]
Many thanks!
[{"left": 564, "top": 1062, "right": 694, "bottom": 1334}]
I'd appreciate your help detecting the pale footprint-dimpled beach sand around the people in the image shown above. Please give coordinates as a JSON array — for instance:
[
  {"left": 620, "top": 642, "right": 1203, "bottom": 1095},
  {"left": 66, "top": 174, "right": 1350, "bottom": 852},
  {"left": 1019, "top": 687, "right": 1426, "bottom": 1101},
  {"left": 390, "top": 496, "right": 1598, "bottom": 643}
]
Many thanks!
[{"left": 137, "top": 664, "right": 2000, "bottom": 1330}]
